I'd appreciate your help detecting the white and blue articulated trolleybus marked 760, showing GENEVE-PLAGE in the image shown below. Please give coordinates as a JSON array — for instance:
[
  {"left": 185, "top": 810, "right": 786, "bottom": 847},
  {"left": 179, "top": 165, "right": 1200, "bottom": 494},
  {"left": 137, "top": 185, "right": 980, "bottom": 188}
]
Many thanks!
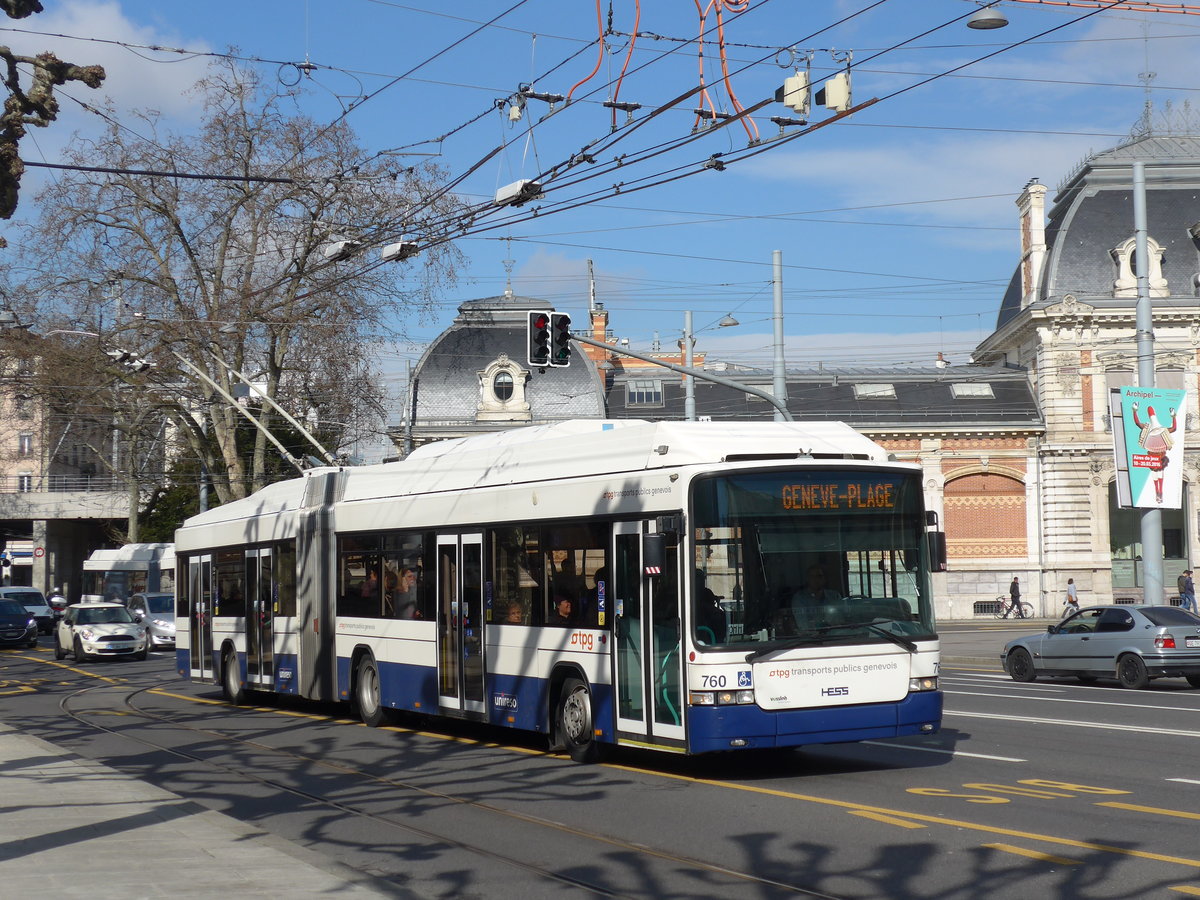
[{"left": 175, "top": 420, "right": 944, "bottom": 761}]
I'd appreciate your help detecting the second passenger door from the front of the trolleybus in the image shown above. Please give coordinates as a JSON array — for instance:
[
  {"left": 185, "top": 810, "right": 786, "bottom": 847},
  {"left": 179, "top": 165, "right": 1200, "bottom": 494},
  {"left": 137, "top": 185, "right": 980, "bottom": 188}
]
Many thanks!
[{"left": 437, "top": 534, "right": 486, "bottom": 714}]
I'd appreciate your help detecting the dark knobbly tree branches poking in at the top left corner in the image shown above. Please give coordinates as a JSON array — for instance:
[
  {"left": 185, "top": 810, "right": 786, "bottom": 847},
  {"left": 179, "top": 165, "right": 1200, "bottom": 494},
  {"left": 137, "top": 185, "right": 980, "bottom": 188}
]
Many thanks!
[{"left": 0, "top": 0, "right": 104, "bottom": 232}]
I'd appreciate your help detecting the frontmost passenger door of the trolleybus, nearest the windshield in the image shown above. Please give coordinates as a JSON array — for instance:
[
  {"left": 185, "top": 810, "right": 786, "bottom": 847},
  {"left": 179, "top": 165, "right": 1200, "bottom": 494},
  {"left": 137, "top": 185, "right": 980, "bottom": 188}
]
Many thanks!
[{"left": 612, "top": 522, "right": 685, "bottom": 743}]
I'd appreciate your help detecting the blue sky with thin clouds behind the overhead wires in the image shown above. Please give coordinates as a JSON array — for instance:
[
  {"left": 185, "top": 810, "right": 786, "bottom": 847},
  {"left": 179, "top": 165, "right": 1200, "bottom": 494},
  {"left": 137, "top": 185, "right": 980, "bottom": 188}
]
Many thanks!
[{"left": 0, "top": 0, "right": 1200, "bottom": 381}]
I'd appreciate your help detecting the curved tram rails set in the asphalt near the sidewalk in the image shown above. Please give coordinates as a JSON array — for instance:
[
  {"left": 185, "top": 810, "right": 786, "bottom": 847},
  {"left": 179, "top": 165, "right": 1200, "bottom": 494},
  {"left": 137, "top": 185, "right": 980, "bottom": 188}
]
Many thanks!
[{"left": 59, "top": 684, "right": 838, "bottom": 900}]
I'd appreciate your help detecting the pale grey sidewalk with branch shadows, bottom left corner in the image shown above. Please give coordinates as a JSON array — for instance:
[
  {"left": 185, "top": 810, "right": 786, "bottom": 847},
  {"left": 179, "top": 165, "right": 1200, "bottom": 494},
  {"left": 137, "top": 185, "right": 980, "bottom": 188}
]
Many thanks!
[{"left": 0, "top": 724, "right": 403, "bottom": 900}]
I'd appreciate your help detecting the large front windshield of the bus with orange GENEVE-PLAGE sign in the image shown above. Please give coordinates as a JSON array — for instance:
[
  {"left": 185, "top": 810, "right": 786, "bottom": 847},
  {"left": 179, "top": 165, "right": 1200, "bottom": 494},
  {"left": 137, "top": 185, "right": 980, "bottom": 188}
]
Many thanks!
[{"left": 691, "top": 468, "right": 934, "bottom": 650}]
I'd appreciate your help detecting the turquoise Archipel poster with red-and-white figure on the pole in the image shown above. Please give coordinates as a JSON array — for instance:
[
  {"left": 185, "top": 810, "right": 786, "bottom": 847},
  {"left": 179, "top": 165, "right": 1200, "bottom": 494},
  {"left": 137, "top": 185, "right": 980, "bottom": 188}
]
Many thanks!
[{"left": 1109, "top": 388, "right": 1187, "bottom": 509}]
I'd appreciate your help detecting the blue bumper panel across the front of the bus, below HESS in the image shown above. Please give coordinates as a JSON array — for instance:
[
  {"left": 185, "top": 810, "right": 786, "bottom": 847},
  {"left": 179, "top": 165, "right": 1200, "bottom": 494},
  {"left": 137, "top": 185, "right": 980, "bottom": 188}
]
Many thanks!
[{"left": 688, "top": 691, "right": 942, "bottom": 754}]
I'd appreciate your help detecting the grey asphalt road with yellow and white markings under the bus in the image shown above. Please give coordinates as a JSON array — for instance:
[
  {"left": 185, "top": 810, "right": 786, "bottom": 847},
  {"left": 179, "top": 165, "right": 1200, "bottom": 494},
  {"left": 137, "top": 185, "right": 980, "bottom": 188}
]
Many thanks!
[{"left": 0, "top": 622, "right": 1200, "bottom": 900}]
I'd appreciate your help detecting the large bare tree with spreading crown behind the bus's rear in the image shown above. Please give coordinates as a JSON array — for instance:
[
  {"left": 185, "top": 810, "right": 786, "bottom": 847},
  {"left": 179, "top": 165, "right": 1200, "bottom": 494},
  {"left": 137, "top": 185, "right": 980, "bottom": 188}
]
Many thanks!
[{"left": 19, "top": 62, "right": 458, "bottom": 511}]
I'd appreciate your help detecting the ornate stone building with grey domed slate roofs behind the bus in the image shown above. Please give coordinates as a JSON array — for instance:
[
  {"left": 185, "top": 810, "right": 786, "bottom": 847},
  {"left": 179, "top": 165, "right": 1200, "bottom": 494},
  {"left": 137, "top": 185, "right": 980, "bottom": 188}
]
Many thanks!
[{"left": 394, "top": 127, "right": 1200, "bottom": 618}]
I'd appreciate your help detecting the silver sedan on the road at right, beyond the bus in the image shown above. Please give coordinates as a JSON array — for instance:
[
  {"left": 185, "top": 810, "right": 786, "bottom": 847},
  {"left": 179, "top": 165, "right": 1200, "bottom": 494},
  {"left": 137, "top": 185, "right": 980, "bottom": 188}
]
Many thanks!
[{"left": 1000, "top": 606, "right": 1200, "bottom": 688}]
